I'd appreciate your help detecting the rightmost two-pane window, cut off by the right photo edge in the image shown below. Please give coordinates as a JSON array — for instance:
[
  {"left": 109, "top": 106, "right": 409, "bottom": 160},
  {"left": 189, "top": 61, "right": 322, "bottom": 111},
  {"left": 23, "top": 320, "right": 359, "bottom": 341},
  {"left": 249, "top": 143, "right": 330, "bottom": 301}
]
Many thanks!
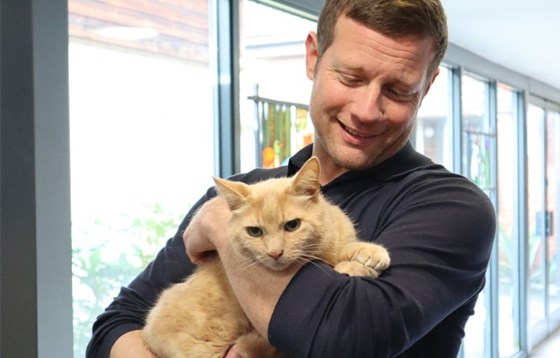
[{"left": 526, "top": 98, "right": 560, "bottom": 347}]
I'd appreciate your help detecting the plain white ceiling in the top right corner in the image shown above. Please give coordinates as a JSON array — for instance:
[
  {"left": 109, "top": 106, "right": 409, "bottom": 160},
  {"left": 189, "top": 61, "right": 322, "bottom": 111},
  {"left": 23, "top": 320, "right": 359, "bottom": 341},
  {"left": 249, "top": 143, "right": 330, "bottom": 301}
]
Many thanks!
[{"left": 442, "top": 0, "right": 560, "bottom": 89}]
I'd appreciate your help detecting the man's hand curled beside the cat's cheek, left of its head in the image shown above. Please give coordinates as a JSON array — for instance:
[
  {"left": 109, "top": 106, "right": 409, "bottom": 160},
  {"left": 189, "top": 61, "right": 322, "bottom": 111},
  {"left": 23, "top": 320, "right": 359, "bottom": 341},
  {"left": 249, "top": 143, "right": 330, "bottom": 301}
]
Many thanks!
[{"left": 183, "top": 196, "right": 231, "bottom": 264}]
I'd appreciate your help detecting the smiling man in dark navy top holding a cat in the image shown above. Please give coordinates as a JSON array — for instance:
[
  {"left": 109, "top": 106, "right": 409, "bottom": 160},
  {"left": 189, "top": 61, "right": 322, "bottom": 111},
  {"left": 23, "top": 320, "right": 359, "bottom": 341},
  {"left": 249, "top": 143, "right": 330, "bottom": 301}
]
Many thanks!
[{"left": 88, "top": 0, "right": 495, "bottom": 358}]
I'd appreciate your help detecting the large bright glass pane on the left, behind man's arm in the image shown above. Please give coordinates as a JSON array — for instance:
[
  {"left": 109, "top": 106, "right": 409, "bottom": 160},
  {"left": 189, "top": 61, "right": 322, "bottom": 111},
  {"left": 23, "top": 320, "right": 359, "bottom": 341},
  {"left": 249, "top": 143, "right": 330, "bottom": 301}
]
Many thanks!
[{"left": 68, "top": 0, "right": 214, "bottom": 357}]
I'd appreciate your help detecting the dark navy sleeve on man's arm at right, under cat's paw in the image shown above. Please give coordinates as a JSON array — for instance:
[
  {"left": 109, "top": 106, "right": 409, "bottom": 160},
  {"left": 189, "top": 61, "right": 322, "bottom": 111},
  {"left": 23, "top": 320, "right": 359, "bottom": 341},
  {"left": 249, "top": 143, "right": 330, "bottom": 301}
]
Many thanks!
[{"left": 268, "top": 173, "right": 496, "bottom": 357}]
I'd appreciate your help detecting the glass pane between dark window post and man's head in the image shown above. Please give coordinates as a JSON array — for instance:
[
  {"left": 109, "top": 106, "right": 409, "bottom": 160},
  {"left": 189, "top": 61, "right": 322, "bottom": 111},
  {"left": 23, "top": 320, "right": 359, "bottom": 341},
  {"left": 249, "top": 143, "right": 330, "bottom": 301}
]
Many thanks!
[{"left": 240, "top": 0, "right": 316, "bottom": 171}]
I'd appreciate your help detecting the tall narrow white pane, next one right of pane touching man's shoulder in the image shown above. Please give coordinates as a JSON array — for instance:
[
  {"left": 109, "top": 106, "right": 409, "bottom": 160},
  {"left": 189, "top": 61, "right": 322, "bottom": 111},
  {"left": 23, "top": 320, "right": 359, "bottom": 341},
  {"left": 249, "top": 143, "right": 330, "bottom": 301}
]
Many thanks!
[{"left": 497, "top": 85, "right": 520, "bottom": 358}]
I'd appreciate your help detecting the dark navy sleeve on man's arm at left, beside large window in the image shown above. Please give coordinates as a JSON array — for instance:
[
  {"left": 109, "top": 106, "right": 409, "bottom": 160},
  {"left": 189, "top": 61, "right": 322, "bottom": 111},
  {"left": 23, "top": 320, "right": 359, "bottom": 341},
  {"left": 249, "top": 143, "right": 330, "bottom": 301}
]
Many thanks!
[{"left": 86, "top": 189, "right": 215, "bottom": 358}]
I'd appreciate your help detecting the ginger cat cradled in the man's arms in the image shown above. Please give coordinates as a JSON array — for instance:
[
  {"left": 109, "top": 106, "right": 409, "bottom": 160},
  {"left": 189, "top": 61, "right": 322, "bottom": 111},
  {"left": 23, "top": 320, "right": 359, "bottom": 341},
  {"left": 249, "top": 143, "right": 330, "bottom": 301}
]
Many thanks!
[{"left": 143, "top": 157, "right": 390, "bottom": 358}]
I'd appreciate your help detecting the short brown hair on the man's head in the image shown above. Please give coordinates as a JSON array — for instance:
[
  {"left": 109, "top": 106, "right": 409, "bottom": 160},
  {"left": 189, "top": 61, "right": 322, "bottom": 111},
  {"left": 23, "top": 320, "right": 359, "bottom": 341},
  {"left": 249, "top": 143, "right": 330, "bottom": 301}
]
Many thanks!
[{"left": 317, "top": 0, "right": 447, "bottom": 73}]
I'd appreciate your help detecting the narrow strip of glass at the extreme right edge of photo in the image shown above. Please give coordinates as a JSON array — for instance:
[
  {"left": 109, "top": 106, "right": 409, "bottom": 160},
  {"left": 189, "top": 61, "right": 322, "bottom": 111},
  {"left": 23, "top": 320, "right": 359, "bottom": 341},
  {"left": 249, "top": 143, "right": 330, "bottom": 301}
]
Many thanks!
[{"left": 546, "top": 112, "right": 560, "bottom": 313}]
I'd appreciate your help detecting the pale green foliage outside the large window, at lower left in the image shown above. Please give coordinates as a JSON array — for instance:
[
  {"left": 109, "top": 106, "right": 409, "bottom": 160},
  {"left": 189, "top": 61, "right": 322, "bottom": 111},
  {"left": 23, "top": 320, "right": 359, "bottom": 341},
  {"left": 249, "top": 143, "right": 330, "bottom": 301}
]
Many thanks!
[{"left": 72, "top": 204, "right": 182, "bottom": 357}]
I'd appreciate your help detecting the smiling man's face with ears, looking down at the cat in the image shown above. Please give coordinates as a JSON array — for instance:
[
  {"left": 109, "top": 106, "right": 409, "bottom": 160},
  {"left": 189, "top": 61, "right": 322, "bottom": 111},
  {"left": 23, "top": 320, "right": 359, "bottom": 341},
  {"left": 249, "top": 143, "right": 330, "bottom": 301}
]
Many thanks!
[{"left": 306, "top": 16, "right": 437, "bottom": 182}]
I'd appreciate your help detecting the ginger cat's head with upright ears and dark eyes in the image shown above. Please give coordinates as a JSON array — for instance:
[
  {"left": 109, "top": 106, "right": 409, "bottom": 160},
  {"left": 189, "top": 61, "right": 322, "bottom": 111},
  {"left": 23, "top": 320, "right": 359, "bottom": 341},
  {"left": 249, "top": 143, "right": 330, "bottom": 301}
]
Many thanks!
[{"left": 215, "top": 157, "right": 324, "bottom": 270}]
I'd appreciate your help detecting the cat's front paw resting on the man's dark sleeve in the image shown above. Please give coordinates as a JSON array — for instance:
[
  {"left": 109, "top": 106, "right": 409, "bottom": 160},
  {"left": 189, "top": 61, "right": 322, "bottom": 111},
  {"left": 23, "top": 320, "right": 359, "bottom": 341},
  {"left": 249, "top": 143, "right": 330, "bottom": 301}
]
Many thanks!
[{"left": 334, "top": 241, "right": 391, "bottom": 277}]
